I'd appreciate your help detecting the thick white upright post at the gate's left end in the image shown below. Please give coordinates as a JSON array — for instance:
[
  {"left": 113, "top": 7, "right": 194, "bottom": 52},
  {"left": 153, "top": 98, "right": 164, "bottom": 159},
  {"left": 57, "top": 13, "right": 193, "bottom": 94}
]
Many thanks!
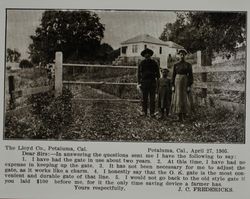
[{"left": 55, "top": 52, "right": 63, "bottom": 96}]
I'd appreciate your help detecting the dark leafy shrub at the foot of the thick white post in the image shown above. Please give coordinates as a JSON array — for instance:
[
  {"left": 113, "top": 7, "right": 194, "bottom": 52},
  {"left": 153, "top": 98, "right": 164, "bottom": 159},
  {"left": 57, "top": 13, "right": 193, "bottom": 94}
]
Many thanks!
[{"left": 30, "top": 89, "right": 72, "bottom": 139}]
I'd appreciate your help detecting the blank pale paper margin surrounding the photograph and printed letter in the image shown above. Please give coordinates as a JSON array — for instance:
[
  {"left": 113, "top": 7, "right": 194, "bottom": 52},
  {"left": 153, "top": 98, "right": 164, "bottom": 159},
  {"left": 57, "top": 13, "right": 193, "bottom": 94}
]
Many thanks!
[{"left": 0, "top": 0, "right": 250, "bottom": 199}]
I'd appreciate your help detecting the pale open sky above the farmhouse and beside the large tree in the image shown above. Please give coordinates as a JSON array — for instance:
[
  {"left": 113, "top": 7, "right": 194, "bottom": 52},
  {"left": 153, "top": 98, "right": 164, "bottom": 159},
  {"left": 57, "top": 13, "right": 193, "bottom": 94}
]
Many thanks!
[{"left": 6, "top": 10, "right": 176, "bottom": 59}]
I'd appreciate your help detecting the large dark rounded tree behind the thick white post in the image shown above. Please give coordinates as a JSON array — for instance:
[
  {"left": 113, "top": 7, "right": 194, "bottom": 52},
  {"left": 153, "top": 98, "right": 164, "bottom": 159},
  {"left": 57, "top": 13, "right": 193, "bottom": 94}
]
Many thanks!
[{"left": 29, "top": 11, "right": 105, "bottom": 63}]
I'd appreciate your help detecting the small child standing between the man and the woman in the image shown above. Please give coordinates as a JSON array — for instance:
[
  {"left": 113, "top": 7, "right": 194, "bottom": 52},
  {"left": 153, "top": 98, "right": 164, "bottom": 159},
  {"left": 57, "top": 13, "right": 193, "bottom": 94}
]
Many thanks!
[{"left": 158, "top": 69, "right": 172, "bottom": 119}]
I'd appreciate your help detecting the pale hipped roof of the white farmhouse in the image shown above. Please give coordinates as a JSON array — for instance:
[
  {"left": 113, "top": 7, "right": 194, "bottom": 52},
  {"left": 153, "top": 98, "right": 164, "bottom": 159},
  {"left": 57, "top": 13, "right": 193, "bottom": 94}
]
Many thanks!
[{"left": 121, "top": 34, "right": 184, "bottom": 49}]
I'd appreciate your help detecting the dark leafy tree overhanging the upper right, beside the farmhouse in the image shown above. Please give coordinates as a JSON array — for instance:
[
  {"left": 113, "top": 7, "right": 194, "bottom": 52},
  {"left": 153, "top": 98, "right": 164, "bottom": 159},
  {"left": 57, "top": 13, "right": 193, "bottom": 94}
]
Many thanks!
[{"left": 160, "top": 12, "right": 246, "bottom": 54}]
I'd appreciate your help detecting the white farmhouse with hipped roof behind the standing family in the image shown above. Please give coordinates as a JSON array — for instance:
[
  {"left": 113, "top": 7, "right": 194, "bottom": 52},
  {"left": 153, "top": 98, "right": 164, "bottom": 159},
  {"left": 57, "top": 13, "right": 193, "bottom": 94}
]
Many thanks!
[{"left": 113, "top": 34, "right": 183, "bottom": 67}]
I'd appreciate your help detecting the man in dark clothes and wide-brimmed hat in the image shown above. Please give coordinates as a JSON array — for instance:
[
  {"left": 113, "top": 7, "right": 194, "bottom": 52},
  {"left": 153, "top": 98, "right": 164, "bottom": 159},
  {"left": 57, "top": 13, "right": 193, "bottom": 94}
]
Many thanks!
[{"left": 137, "top": 48, "right": 160, "bottom": 117}]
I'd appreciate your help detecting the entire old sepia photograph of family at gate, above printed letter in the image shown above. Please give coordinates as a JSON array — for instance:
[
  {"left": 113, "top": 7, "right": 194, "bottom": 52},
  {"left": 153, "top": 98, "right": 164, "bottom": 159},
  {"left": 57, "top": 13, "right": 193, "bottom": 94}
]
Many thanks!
[{"left": 3, "top": 8, "right": 247, "bottom": 144}]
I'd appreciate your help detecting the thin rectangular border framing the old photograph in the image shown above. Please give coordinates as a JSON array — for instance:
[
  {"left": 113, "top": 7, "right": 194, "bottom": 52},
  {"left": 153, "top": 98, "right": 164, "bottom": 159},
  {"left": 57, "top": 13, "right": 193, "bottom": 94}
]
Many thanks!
[{"left": 3, "top": 7, "right": 248, "bottom": 145}]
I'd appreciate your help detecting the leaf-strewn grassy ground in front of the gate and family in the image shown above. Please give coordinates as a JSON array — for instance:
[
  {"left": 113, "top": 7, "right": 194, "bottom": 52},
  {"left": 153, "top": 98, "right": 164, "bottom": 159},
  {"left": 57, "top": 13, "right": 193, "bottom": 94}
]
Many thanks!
[{"left": 5, "top": 87, "right": 245, "bottom": 143}]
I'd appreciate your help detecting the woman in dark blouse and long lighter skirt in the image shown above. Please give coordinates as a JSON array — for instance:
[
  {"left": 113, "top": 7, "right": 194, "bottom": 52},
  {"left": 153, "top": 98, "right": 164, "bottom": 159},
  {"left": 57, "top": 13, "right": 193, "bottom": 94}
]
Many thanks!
[{"left": 171, "top": 49, "right": 193, "bottom": 121}]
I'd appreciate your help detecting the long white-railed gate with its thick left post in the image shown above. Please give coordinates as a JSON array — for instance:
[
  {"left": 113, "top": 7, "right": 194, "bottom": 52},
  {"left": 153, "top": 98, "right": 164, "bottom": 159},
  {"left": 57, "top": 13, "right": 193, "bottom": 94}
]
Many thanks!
[{"left": 55, "top": 52, "right": 140, "bottom": 102}]
